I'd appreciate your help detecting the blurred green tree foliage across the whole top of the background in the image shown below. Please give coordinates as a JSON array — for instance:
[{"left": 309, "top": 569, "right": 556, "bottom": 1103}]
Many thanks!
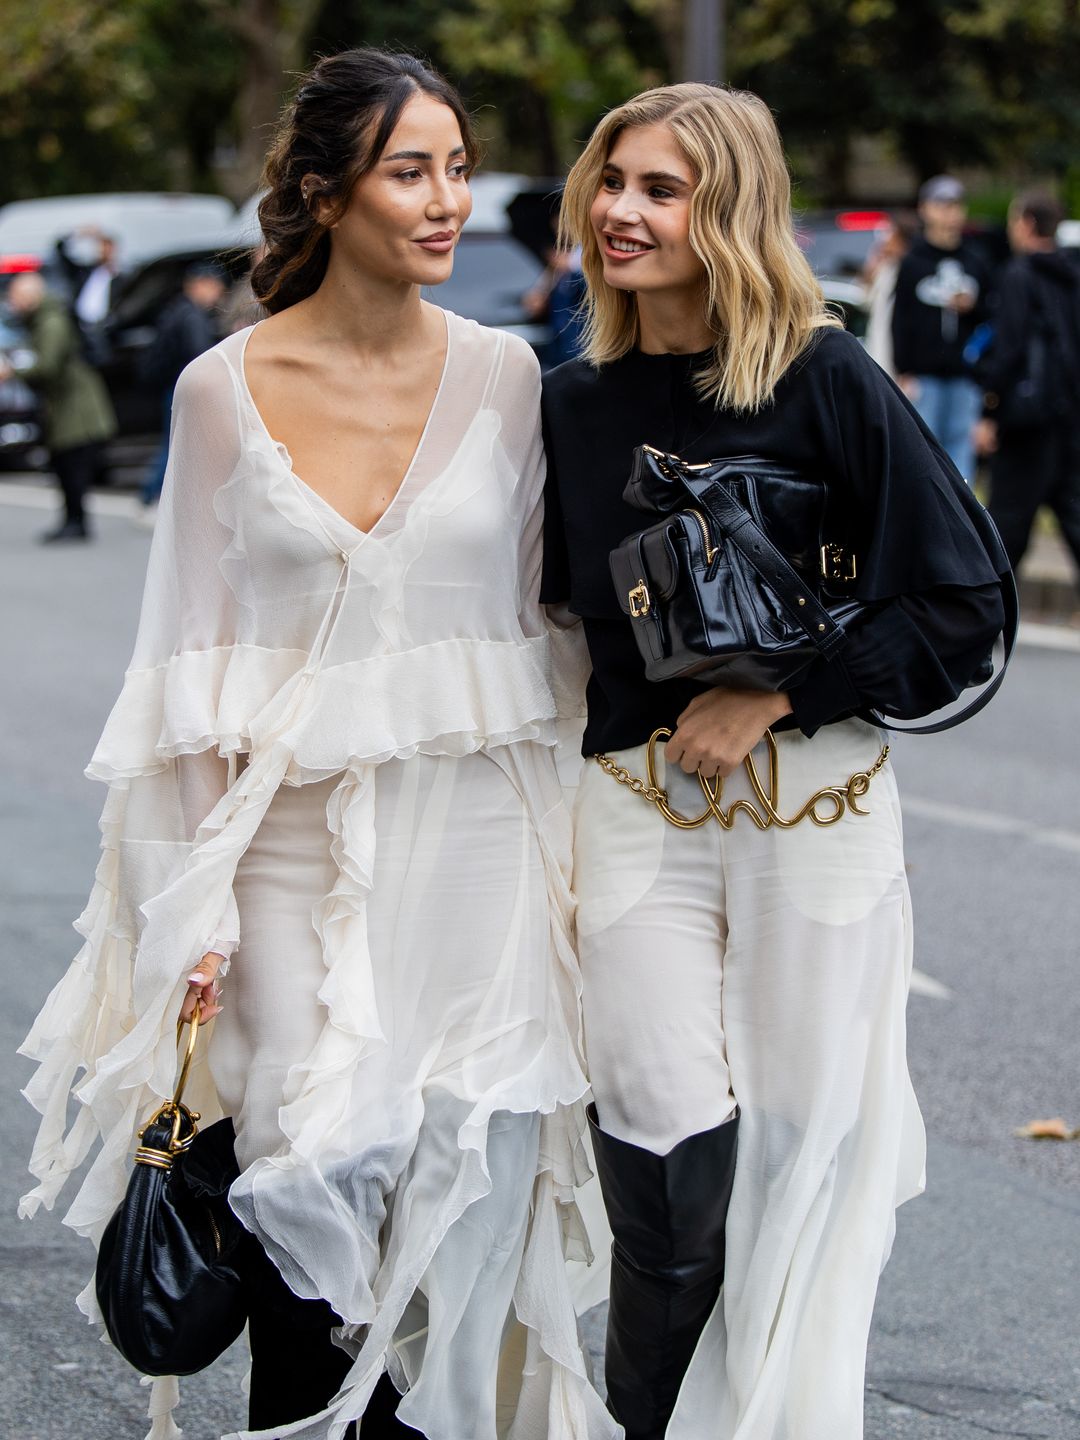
[{"left": 0, "top": 0, "right": 1080, "bottom": 203}]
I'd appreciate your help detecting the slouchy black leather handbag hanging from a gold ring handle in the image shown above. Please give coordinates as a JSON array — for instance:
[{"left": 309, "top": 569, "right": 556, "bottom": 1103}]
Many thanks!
[{"left": 95, "top": 1009, "right": 258, "bottom": 1375}]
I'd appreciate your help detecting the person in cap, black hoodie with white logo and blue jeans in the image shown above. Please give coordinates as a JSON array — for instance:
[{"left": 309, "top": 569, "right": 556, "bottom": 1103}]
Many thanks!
[{"left": 893, "top": 176, "right": 991, "bottom": 484}]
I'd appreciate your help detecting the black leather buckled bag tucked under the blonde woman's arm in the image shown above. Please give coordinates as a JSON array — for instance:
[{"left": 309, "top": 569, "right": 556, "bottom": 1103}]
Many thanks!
[{"left": 611, "top": 445, "right": 1018, "bottom": 734}]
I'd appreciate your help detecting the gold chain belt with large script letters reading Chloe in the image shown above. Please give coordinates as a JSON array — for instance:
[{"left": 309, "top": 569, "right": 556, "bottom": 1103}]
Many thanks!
[{"left": 593, "top": 727, "right": 888, "bottom": 829}]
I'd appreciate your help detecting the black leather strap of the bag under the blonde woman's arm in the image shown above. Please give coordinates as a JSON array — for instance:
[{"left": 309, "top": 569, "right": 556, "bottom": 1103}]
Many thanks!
[{"left": 678, "top": 465, "right": 1020, "bottom": 734}]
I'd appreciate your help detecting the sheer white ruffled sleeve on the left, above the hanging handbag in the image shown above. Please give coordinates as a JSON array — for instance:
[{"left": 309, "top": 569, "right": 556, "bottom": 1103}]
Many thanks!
[{"left": 20, "top": 351, "right": 249, "bottom": 1238}]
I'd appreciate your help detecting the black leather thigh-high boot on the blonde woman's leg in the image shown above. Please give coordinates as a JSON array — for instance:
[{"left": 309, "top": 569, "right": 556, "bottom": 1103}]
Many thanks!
[{"left": 589, "top": 1106, "right": 739, "bottom": 1440}]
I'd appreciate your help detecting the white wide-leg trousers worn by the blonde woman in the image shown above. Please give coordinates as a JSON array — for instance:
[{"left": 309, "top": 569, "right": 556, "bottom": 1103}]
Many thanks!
[{"left": 575, "top": 720, "right": 924, "bottom": 1440}]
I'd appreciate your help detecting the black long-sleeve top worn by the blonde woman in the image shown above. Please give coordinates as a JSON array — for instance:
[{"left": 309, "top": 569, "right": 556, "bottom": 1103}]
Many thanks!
[{"left": 541, "top": 330, "right": 1008, "bottom": 755}]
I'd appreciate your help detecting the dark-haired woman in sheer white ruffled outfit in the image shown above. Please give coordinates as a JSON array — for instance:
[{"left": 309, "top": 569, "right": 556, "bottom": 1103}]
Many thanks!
[{"left": 26, "top": 50, "right": 618, "bottom": 1440}]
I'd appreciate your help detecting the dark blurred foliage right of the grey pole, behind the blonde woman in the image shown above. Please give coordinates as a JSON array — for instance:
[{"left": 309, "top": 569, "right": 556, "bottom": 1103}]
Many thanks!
[{"left": 730, "top": 0, "right": 1080, "bottom": 202}]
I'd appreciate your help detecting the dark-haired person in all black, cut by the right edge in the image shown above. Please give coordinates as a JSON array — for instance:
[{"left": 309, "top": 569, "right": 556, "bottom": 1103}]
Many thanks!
[{"left": 976, "top": 193, "right": 1080, "bottom": 584}]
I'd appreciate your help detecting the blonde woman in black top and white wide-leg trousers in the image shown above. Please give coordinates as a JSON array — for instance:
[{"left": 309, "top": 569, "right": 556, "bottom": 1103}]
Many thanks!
[{"left": 543, "top": 85, "right": 1008, "bottom": 1440}]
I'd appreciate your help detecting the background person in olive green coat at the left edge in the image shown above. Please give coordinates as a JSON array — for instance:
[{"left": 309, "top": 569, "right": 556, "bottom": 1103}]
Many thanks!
[{"left": 0, "top": 272, "right": 117, "bottom": 543}]
